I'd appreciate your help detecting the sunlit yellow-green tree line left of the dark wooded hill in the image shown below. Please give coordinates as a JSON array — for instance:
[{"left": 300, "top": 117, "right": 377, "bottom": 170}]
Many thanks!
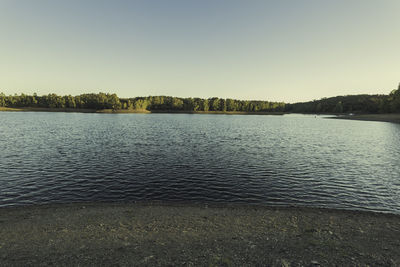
[{"left": 0, "top": 93, "right": 285, "bottom": 112}]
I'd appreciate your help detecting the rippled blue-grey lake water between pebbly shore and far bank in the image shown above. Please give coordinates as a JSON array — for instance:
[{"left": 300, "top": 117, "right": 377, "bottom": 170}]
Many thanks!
[{"left": 0, "top": 112, "right": 400, "bottom": 213}]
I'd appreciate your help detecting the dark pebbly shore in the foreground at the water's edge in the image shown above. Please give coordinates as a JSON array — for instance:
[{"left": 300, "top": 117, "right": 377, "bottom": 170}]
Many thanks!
[{"left": 0, "top": 203, "right": 400, "bottom": 266}]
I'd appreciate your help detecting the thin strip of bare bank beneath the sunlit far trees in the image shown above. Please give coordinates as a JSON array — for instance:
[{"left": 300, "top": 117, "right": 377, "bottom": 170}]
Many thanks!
[{"left": 0, "top": 107, "right": 287, "bottom": 115}]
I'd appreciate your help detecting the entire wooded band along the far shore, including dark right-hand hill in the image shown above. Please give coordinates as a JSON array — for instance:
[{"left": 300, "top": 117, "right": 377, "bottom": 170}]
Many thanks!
[{"left": 0, "top": 85, "right": 400, "bottom": 113}]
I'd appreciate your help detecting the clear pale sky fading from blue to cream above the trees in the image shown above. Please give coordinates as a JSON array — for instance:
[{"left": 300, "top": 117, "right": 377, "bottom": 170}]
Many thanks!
[{"left": 0, "top": 0, "right": 400, "bottom": 102}]
